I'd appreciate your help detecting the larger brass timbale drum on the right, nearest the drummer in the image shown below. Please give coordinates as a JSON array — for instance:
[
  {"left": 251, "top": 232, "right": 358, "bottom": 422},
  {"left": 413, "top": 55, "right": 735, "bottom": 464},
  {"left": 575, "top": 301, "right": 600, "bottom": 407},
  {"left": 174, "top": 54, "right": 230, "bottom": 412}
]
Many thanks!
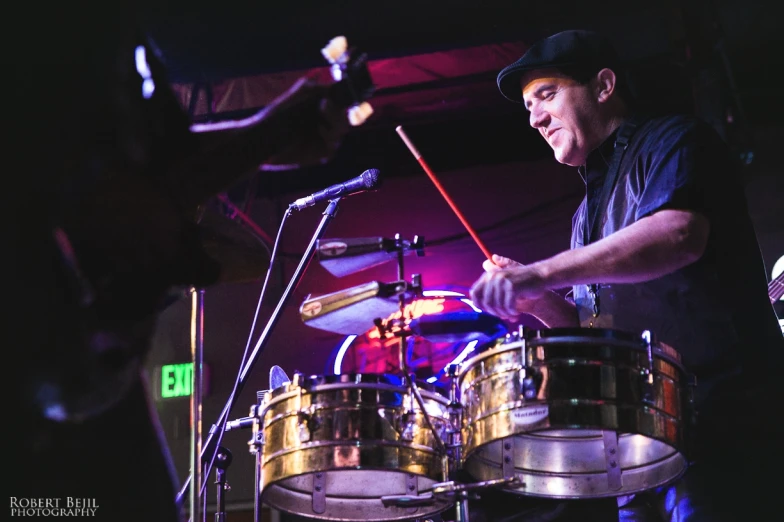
[{"left": 459, "top": 328, "right": 693, "bottom": 499}]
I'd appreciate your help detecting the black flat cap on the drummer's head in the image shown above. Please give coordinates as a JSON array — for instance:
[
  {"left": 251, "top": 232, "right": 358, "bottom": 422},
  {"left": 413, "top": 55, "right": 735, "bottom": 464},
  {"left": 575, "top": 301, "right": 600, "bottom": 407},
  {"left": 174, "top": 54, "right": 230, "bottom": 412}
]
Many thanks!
[{"left": 497, "top": 31, "right": 620, "bottom": 103}]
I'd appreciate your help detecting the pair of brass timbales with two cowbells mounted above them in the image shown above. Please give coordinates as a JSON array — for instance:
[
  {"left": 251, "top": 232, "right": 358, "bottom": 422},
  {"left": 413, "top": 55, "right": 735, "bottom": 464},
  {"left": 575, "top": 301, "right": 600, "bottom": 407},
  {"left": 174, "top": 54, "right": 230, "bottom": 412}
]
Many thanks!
[{"left": 237, "top": 236, "right": 694, "bottom": 522}]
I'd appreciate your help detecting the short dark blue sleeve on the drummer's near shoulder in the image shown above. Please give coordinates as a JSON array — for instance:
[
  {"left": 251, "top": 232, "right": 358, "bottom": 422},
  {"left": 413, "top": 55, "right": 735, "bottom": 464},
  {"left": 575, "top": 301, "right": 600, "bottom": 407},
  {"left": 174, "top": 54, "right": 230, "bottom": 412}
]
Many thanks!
[{"left": 635, "top": 118, "right": 732, "bottom": 220}]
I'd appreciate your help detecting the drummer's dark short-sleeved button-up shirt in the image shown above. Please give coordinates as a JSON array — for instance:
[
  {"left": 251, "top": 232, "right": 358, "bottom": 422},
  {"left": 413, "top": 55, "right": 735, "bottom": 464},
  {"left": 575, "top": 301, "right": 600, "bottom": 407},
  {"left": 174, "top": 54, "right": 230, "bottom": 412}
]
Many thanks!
[{"left": 571, "top": 116, "right": 784, "bottom": 394}]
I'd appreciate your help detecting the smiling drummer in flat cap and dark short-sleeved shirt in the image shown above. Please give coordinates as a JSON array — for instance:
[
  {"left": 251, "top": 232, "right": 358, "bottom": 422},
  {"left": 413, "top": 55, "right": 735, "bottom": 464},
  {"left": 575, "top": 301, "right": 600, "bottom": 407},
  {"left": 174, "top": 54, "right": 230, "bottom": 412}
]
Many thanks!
[{"left": 471, "top": 31, "right": 784, "bottom": 521}]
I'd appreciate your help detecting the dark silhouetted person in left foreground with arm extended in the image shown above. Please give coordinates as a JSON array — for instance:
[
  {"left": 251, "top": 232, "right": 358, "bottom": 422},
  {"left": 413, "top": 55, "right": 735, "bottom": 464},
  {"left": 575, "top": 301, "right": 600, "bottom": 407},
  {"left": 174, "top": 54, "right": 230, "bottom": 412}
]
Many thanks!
[{"left": 9, "top": 2, "right": 358, "bottom": 522}]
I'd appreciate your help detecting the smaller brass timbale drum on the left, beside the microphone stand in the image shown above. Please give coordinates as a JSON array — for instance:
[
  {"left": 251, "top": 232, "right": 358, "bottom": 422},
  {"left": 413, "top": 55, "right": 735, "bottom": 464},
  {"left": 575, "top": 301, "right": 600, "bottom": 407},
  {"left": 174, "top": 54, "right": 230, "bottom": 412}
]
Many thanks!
[{"left": 254, "top": 374, "right": 452, "bottom": 521}]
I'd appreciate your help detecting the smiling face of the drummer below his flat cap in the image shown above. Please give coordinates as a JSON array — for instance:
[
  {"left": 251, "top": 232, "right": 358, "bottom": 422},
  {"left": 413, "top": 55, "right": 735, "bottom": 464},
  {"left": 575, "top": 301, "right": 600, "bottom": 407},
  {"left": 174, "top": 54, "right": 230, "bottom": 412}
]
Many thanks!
[{"left": 520, "top": 70, "right": 600, "bottom": 167}]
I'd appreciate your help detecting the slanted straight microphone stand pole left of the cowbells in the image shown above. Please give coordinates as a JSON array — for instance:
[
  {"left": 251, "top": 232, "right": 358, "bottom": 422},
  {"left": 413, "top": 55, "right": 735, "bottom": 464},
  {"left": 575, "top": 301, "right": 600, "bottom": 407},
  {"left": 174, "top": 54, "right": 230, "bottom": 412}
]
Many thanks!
[{"left": 175, "top": 197, "right": 340, "bottom": 512}]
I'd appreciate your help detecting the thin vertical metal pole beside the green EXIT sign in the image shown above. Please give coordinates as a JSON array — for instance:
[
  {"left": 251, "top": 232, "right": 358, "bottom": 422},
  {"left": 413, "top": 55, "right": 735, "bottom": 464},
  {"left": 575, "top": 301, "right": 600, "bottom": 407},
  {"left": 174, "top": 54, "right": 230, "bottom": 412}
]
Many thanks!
[{"left": 189, "top": 288, "right": 204, "bottom": 522}]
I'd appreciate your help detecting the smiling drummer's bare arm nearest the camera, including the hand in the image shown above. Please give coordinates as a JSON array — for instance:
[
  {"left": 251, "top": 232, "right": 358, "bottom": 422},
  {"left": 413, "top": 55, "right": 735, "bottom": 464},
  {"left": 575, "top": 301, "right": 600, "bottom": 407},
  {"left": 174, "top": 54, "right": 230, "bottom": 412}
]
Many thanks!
[{"left": 471, "top": 210, "right": 710, "bottom": 317}]
